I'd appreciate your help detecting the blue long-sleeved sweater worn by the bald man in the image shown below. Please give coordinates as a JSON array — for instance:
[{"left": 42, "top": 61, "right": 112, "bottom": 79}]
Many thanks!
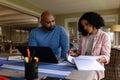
[{"left": 29, "top": 26, "right": 69, "bottom": 59}]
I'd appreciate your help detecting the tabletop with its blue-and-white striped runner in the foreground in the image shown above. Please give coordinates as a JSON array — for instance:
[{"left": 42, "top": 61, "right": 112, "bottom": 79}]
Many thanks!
[{"left": 0, "top": 57, "right": 96, "bottom": 80}]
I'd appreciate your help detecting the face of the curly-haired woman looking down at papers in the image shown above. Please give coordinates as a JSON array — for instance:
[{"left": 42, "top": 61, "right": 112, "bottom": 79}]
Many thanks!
[{"left": 81, "top": 19, "right": 97, "bottom": 34}]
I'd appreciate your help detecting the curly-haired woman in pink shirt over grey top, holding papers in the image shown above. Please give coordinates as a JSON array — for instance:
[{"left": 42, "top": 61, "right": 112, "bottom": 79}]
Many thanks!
[{"left": 68, "top": 12, "right": 111, "bottom": 80}]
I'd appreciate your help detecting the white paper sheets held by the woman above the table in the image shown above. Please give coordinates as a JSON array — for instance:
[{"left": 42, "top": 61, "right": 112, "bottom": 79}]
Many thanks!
[{"left": 68, "top": 56, "right": 105, "bottom": 70}]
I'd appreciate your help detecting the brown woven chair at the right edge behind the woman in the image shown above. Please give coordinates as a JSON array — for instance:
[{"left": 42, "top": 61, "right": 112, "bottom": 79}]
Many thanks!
[{"left": 103, "top": 48, "right": 120, "bottom": 80}]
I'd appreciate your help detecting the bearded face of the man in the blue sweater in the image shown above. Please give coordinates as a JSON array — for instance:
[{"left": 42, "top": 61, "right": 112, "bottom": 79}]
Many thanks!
[{"left": 41, "top": 15, "right": 55, "bottom": 31}]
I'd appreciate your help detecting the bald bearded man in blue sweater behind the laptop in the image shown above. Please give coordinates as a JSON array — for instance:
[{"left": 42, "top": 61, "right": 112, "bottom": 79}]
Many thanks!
[{"left": 29, "top": 11, "right": 69, "bottom": 59}]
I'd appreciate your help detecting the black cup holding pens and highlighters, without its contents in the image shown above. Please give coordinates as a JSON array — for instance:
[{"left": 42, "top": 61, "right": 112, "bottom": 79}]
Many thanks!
[{"left": 25, "top": 62, "right": 38, "bottom": 80}]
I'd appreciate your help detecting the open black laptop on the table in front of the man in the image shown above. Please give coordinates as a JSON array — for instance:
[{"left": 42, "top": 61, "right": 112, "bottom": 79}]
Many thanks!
[{"left": 16, "top": 46, "right": 58, "bottom": 63}]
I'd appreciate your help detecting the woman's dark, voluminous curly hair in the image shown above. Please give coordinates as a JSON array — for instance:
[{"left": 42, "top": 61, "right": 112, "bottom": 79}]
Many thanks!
[{"left": 78, "top": 12, "right": 105, "bottom": 36}]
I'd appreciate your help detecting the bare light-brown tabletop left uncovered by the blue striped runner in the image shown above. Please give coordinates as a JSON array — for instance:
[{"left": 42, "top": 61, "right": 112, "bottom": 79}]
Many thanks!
[{"left": 0, "top": 70, "right": 96, "bottom": 80}]
